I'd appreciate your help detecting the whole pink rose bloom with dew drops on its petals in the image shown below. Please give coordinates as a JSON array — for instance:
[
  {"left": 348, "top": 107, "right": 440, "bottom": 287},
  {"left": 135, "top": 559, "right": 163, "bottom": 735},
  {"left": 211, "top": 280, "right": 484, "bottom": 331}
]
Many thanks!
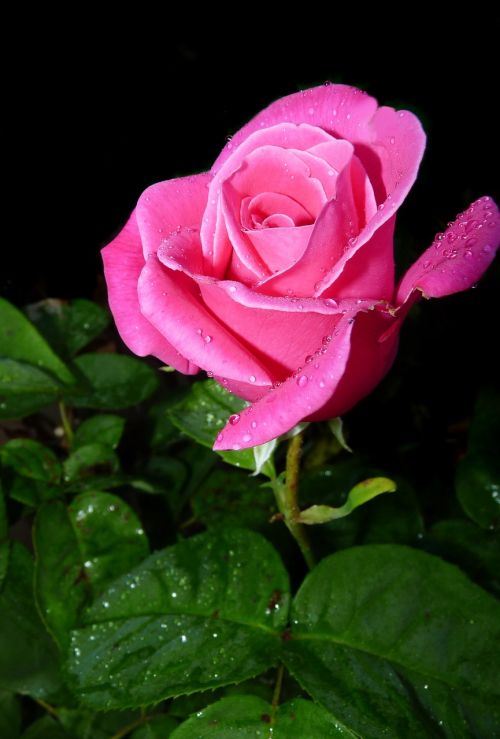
[{"left": 103, "top": 85, "right": 500, "bottom": 449}]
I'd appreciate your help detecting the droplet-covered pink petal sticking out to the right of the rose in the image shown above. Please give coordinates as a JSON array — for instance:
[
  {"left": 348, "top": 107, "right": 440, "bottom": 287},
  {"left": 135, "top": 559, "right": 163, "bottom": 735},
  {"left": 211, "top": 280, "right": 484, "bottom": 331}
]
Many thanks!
[{"left": 396, "top": 197, "right": 500, "bottom": 306}]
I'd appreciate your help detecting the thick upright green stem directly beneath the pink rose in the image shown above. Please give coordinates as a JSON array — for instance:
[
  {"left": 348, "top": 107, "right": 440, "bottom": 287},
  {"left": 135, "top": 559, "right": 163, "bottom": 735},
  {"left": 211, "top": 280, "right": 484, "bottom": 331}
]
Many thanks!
[{"left": 273, "top": 434, "right": 316, "bottom": 570}]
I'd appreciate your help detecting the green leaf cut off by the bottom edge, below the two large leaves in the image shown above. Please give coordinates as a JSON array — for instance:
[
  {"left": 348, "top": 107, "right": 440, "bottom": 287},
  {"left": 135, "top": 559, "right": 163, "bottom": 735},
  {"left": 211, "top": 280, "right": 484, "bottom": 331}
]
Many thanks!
[{"left": 171, "top": 695, "right": 356, "bottom": 739}]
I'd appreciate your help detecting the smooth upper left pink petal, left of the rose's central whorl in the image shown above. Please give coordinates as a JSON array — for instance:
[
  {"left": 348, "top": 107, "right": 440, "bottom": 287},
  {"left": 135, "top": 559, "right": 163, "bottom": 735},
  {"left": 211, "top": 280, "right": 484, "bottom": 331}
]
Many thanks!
[{"left": 136, "top": 172, "right": 212, "bottom": 257}]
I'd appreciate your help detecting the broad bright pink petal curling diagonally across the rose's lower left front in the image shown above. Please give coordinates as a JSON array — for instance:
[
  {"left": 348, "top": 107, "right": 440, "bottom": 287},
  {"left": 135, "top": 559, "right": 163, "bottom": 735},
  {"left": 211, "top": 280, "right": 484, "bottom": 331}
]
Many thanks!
[{"left": 138, "top": 247, "right": 272, "bottom": 385}]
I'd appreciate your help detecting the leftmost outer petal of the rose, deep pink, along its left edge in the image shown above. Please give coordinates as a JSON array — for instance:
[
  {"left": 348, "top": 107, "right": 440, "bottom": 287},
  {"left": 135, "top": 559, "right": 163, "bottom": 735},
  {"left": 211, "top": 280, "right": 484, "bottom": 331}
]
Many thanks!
[{"left": 101, "top": 211, "right": 198, "bottom": 375}]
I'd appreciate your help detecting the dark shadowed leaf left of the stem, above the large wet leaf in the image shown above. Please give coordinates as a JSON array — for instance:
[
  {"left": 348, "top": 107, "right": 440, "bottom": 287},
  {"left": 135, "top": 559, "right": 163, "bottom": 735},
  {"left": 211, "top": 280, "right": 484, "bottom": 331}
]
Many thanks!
[{"left": 191, "top": 467, "right": 276, "bottom": 531}]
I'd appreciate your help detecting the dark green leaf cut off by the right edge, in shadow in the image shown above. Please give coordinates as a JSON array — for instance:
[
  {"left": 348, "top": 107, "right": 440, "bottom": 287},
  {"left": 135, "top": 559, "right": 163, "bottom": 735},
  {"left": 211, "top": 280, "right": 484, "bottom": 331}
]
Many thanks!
[{"left": 455, "top": 389, "right": 500, "bottom": 529}]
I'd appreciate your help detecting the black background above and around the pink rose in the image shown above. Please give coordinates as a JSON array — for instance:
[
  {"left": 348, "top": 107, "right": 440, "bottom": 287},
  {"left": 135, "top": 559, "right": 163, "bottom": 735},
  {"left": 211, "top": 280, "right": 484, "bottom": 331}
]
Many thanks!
[{"left": 0, "top": 27, "right": 500, "bottom": 434}]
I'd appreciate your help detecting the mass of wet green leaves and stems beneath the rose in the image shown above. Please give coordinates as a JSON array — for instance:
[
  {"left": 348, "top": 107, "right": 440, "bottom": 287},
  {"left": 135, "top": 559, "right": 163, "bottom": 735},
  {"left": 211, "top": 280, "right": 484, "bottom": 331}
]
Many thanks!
[{"left": 0, "top": 300, "right": 500, "bottom": 739}]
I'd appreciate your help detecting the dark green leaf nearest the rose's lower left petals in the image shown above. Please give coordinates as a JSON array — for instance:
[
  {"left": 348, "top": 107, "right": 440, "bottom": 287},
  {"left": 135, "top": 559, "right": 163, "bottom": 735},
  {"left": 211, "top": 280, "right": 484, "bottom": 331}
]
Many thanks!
[{"left": 68, "top": 354, "right": 158, "bottom": 410}]
